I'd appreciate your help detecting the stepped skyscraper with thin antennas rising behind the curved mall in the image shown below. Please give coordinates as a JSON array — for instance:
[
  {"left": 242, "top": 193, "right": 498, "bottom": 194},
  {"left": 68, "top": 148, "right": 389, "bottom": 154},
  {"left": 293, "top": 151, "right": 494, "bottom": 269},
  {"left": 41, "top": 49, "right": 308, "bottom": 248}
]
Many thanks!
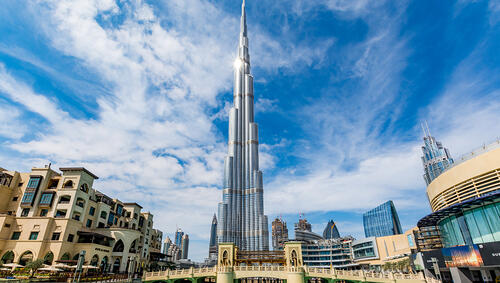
[{"left": 422, "top": 123, "right": 453, "bottom": 185}]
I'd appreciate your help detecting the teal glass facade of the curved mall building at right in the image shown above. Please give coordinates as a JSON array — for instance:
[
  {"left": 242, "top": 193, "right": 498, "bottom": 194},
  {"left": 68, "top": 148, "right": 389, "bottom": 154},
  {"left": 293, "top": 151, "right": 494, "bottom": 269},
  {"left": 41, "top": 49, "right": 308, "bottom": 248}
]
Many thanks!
[{"left": 439, "top": 199, "right": 500, "bottom": 247}]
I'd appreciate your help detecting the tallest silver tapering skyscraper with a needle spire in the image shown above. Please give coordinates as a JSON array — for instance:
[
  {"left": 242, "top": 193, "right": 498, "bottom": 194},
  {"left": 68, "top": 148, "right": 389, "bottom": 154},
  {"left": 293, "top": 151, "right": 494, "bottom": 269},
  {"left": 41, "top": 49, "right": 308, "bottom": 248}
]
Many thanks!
[{"left": 217, "top": 1, "right": 269, "bottom": 253}]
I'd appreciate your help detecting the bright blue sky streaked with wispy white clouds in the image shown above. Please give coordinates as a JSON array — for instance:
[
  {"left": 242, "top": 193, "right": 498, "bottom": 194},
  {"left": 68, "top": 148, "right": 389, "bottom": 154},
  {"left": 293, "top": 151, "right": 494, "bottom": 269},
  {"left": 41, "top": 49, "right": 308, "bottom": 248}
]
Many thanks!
[{"left": 0, "top": 0, "right": 500, "bottom": 261}]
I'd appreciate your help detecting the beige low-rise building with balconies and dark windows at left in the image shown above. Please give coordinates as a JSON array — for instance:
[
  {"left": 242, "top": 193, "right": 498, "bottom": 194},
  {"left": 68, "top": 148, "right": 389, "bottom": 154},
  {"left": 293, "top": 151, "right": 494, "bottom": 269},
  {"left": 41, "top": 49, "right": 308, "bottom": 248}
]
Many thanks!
[{"left": 0, "top": 165, "right": 161, "bottom": 273}]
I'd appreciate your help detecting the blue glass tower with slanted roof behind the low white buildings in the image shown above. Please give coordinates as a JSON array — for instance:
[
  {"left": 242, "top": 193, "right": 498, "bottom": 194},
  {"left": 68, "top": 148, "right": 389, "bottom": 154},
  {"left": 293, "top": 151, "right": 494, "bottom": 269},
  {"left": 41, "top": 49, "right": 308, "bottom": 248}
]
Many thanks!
[{"left": 363, "top": 200, "right": 402, "bottom": 238}]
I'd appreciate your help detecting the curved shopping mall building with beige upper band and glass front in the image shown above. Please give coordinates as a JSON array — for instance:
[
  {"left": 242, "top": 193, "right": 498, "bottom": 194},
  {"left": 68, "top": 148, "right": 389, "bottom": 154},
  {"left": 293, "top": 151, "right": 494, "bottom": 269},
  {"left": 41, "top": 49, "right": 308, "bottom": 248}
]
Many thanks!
[{"left": 416, "top": 141, "right": 500, "bottom": 282}]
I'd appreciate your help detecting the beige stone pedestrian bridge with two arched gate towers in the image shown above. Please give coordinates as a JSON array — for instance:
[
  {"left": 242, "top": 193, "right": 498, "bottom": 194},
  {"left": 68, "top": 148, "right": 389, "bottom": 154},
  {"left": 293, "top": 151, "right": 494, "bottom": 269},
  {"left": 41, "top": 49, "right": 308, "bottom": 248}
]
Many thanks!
[{"left": 143, "top": 242, "right": 440, "bottom": 283}]
